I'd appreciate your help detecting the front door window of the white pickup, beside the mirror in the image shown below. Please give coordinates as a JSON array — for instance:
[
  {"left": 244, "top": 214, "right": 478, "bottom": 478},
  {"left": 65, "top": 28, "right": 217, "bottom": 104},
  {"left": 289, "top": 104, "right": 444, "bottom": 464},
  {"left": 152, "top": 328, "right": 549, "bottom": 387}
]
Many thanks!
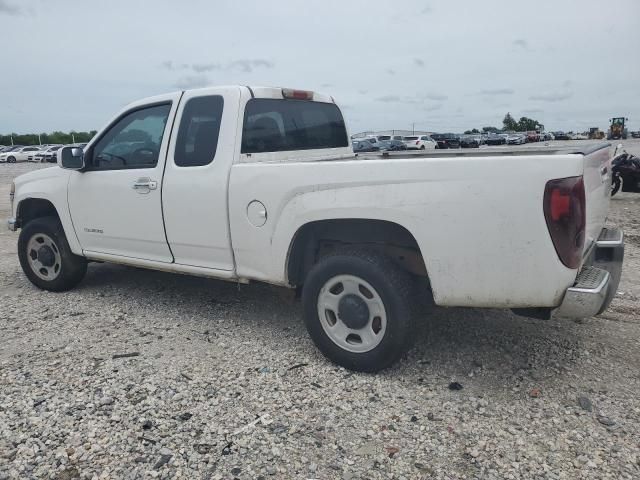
[{"left": 90, "top": 104, "right": 171, "bottom": 170}]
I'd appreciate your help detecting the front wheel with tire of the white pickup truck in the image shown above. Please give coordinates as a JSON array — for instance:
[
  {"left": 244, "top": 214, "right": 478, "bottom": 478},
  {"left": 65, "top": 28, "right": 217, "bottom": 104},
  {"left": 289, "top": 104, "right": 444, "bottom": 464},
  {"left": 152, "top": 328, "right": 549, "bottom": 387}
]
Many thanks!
[{"left": 18, "top": 217, "right": 87, "bottom": 292}]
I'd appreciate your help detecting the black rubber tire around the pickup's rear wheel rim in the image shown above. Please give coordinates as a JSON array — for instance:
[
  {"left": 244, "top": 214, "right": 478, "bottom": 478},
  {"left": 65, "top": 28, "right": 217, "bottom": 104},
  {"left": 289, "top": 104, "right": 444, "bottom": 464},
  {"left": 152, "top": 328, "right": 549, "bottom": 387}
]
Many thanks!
[{"left": 302, "top": 249, "right": 415, "bottom": 372}]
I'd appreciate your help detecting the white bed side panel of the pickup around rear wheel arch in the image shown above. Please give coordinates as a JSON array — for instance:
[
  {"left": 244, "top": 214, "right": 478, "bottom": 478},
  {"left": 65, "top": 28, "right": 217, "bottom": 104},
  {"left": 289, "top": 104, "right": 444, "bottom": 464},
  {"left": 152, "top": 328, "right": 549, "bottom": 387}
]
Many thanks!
[{"left": 229, "top": 155, "right": 583, "bottom": 307}]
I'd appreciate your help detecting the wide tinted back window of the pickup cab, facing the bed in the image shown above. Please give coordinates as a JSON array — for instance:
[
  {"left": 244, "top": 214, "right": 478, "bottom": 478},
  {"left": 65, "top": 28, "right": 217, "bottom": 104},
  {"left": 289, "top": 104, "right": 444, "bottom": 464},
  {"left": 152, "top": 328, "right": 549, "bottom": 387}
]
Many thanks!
[{"left": 241, "top": 98, "right": 349, "bottom": 153}]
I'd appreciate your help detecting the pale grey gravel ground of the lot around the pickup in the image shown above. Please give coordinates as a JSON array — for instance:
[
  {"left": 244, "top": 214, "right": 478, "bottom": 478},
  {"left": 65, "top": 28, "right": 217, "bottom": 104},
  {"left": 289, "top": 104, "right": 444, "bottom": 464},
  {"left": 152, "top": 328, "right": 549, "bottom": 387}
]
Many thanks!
[{"left": 0, "top": 140, "right": 640, "bottom": 479}]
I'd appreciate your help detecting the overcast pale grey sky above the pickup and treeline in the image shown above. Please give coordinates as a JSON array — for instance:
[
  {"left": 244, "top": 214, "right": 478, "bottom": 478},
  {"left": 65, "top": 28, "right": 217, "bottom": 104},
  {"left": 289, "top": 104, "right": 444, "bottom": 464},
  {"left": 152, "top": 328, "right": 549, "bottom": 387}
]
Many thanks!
[{"left": 0, "top": 0, "right": 640, "bottom": 133}]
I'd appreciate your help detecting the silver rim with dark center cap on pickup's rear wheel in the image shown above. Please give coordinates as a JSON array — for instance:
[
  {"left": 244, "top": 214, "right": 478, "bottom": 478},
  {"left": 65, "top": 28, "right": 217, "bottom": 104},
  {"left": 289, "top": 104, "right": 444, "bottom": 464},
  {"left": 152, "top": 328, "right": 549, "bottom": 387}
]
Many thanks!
[{"left": 318, "top": 275, "right": 387, "bottom": 353}]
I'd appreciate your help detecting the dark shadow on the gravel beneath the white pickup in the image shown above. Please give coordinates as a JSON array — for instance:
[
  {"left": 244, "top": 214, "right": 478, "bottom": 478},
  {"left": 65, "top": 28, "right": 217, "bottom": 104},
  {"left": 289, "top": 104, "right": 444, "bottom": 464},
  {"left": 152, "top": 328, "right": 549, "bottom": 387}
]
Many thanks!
[{"left": 79, "top": 264, "right": 594, "bottom": 380}]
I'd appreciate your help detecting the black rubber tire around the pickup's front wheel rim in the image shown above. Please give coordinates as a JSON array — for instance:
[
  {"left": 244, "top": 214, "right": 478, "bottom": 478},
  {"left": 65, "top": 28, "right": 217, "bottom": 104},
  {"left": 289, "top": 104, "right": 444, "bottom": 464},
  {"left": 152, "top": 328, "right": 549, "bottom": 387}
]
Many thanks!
[{"left": 18, "top": 217, "right": 87, "bottom": 292}]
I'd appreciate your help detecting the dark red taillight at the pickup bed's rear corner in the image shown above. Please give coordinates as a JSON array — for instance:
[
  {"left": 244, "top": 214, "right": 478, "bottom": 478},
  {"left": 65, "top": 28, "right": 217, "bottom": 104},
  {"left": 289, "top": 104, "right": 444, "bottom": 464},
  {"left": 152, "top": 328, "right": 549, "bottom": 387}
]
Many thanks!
[{"left": 544, "top": 176, "right": 586, "bottom": 268}]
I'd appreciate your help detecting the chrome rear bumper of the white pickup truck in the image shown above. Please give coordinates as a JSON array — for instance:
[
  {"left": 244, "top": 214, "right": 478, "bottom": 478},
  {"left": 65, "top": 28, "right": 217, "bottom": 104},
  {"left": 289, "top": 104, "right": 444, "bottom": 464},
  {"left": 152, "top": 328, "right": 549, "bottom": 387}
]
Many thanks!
[{"left": 554, "top": 227, "right": 624, "bottom": 318}]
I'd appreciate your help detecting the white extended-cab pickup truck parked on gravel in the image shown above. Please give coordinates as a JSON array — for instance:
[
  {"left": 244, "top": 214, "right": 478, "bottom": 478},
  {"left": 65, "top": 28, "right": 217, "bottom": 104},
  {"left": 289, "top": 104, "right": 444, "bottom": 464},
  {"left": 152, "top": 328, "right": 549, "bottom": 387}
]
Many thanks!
[{"left": 9, "top": 86, "right": 624, "bottom": 371}]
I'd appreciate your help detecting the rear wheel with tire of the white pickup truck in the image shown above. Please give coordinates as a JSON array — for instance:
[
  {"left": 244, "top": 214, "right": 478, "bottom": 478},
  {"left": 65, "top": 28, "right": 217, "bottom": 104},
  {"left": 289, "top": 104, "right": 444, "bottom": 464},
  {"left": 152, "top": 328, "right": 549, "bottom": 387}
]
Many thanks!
[{"left": 302, "top": 249, "right": 414, "bottom": 372}]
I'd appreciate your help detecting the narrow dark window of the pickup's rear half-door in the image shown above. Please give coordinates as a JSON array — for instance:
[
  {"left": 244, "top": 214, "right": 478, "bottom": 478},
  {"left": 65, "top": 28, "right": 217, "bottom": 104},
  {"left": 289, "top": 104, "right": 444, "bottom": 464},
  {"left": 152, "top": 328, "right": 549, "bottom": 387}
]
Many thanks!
[{"left": 174, "top": 95, "right": 224, "bottom": 167}]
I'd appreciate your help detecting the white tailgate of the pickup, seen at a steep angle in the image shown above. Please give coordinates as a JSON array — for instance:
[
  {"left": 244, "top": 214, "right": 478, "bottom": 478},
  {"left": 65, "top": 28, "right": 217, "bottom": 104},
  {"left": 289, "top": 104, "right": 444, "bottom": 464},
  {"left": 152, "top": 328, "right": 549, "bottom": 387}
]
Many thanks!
[{"left": 577, "top": 144, "right": 611, "bottom": 252}]
